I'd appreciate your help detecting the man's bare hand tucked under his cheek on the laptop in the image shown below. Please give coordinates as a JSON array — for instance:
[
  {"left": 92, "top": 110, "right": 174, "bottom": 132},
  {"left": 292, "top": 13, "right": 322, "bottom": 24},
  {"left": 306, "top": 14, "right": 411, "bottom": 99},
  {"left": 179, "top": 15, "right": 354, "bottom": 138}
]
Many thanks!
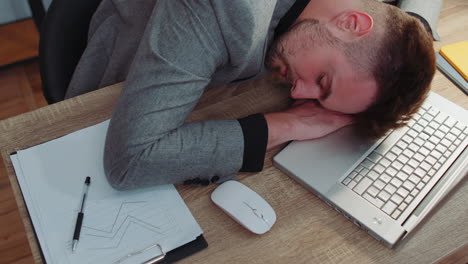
[{"left": 265, "top": 100, "right": 353, "bottom": 149}]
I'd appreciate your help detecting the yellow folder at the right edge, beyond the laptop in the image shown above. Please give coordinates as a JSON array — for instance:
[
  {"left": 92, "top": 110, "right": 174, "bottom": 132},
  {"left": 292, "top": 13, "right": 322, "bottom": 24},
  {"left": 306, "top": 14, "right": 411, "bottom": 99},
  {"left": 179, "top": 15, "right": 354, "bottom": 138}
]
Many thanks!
[{"left": 440, "top": 41, "right": 468, "bottom": 81}]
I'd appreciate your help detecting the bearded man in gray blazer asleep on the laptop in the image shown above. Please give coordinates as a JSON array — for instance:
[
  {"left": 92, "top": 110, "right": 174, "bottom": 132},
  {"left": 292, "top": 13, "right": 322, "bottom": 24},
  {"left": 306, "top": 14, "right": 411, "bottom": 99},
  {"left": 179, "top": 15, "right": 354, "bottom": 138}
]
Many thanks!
[{"left": 67, "top": 0, "right": 435, "bottom": 189}]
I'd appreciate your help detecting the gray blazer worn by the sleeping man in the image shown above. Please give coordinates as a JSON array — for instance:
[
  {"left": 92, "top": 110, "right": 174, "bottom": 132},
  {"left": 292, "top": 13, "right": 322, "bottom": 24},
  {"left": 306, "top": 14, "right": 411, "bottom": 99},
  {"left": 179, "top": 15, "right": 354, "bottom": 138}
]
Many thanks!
[{"left": 67, "top": 0, "right": 294, "bottom": 189}]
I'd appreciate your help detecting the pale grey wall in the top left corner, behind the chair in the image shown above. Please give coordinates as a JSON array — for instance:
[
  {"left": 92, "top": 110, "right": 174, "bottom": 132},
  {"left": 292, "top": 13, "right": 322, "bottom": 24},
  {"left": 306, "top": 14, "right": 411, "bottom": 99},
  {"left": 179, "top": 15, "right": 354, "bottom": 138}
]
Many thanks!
[{"left": 0, "top": 0, "right": 53, "bottom": 25}]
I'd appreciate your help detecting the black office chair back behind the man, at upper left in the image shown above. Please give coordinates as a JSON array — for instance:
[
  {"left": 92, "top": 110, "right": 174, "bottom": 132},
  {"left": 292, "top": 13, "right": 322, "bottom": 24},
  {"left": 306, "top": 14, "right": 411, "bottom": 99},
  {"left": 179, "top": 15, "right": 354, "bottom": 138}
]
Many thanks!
[{"left": 39, "top": 0, "right": 101, "bottom": 104}]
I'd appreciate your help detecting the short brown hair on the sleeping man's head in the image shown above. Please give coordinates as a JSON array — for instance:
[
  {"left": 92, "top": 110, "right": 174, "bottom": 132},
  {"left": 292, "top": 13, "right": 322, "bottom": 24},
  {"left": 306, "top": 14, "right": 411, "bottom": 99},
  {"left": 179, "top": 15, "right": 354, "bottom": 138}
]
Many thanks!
[{"left": 356, "top": 0, "right": 436, "bottom": 137}]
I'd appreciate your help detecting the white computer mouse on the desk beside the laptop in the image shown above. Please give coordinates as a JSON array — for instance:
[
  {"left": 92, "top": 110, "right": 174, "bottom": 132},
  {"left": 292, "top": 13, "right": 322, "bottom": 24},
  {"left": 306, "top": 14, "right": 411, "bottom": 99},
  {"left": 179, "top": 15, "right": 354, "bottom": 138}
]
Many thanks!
[{"left": 211, "top": 181, "right": 276, "bottom": 235}]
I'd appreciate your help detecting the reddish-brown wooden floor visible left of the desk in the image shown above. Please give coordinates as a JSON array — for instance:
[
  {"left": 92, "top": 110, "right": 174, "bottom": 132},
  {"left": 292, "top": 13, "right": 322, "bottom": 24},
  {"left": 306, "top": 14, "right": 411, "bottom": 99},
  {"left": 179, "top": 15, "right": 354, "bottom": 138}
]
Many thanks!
[{"left": 0, "top": 20, "right": 47, "bottom": 264}]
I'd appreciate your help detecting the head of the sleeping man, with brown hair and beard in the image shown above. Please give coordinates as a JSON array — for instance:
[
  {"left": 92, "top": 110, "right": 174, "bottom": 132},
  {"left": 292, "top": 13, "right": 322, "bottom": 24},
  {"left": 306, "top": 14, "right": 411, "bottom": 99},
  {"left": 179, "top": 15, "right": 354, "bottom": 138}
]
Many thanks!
[{"left": 267, "top": 0, "right": 435, "bottom": 139}]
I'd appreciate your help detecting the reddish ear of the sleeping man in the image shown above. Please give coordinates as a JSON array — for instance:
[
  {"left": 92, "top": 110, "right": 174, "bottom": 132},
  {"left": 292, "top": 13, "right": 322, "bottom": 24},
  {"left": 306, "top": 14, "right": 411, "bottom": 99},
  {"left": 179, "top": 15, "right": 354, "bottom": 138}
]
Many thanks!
[{"left": 327, "top": 10, "right": 374, "bottom": 41}]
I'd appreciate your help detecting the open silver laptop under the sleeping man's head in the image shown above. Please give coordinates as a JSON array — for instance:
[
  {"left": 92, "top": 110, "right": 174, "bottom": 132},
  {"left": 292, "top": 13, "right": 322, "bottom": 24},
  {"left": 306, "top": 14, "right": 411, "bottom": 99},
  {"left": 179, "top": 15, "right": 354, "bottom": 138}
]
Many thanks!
[{"left": 273, "top": 92, "right": 468, "bottom": 248}]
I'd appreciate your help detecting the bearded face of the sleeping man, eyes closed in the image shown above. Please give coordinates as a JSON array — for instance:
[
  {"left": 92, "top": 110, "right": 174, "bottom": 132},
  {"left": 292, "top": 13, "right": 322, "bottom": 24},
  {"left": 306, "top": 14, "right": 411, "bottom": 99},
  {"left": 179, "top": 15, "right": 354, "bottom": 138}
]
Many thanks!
[{"left": 267, "top": 20, "right": 377, "bottom": 114}]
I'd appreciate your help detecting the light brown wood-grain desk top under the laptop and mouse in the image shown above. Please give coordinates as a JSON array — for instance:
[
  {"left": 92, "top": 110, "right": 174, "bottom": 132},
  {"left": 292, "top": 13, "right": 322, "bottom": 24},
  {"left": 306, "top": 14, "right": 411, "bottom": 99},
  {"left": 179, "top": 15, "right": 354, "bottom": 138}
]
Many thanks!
[{"left": 0, "top": 0, "right": 468, "bottom": 263}]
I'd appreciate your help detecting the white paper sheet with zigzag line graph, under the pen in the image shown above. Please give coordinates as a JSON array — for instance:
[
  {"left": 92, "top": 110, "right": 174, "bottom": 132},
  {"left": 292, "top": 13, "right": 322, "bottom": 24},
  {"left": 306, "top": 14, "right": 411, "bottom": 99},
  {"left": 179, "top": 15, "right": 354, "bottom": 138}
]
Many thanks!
[{"left": 12, "top": 121, "right": 202, "bottom": 263}]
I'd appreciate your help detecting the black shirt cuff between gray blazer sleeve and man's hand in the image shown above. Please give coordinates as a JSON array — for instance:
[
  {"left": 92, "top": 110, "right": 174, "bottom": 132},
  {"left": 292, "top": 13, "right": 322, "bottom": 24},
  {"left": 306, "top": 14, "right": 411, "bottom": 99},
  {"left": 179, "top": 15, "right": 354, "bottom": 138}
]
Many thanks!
[{"left": 238, "top": 114, "right": 268, "bottom": 172}]
